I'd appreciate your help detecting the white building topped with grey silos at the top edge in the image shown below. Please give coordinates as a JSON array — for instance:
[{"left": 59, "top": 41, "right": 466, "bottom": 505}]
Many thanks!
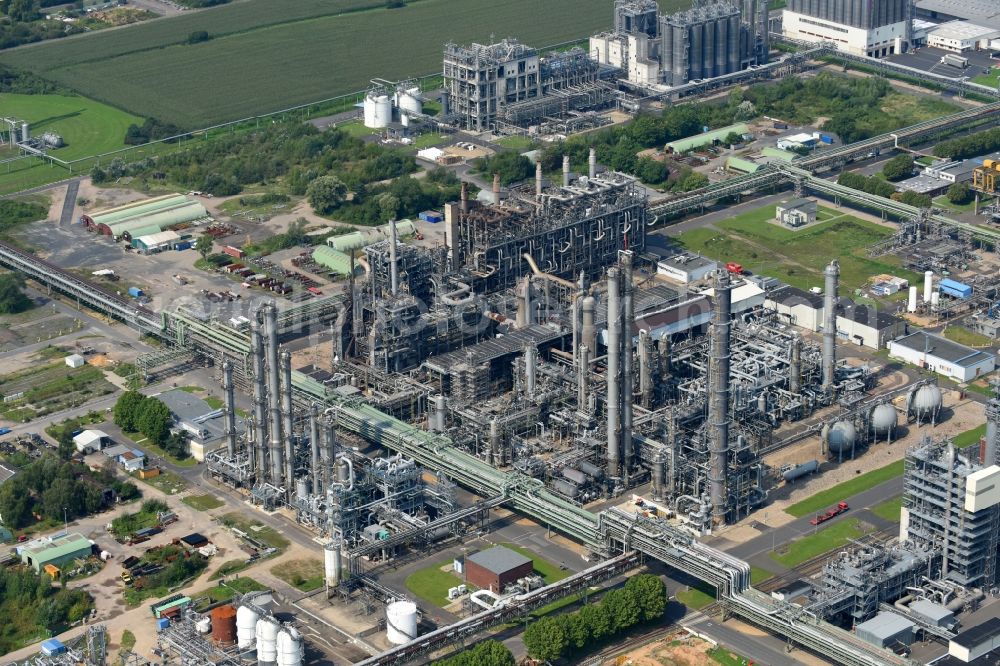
[{"left": 782, "top": 0, "right": 913, "bottom": 58}]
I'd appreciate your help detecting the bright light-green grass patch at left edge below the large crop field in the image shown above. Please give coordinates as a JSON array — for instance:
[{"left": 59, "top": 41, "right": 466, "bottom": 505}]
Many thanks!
[{"left": 0, "top": 94, "right": 142, "bottom": 194}]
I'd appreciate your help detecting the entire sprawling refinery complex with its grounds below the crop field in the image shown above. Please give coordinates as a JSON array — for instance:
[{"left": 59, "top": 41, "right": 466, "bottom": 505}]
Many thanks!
[{"left": 7, "top": 0, "right": 1000, "bottom": 666}]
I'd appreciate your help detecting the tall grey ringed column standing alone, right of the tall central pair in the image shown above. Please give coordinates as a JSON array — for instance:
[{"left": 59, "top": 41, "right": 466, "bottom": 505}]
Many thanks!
[{"left": 708, "top": 272, "right": 732, "bottom": 524}]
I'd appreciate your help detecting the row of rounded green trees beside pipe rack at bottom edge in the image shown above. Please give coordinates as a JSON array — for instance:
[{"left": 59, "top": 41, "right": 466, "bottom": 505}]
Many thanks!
[{"left": 523, "top": 574, "right": 667, "bottom": 661}]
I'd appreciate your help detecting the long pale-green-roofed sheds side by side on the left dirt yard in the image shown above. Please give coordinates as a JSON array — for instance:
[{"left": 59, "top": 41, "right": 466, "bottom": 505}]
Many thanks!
[{"left": 80, "top": 194, "right": 208, "bottom": 241}]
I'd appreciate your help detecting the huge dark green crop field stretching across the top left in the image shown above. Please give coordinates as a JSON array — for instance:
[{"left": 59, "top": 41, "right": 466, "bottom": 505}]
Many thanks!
[{"left": 0, "top": 0, "right": 673, "bottom": 128}]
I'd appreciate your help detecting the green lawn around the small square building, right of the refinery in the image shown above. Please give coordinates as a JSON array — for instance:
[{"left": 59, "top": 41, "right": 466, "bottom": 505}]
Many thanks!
[{"left": 677, "top": 206, "right": 920, "bottom": 293}]
